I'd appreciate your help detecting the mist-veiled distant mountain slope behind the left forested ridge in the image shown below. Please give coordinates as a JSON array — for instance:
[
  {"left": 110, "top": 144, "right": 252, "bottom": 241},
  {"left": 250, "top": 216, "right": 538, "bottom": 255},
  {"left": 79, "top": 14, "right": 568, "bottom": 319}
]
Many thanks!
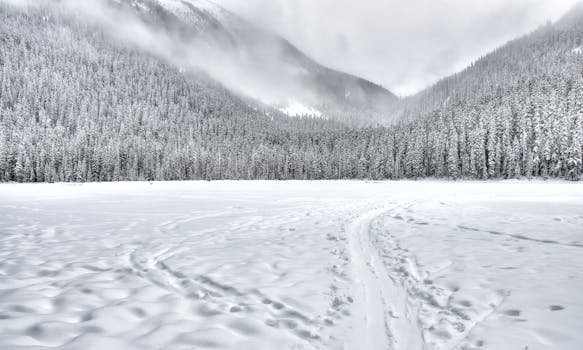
[{"left": 53, "top": 0, "right": 396, "bottom": 121}]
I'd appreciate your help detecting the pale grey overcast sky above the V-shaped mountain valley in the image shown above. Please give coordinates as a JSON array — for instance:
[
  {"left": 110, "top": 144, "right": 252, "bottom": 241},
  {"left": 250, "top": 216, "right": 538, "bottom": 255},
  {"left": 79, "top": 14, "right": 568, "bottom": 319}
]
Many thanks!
[{"left": 215, "top": 0, "right": 578, "bottom": 96}]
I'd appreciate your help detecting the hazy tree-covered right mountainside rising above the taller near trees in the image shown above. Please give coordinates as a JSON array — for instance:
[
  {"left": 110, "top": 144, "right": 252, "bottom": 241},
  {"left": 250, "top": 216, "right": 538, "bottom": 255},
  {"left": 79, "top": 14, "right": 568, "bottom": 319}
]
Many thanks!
[{"left": 390, "top": 3, "right": 583, "bottom": 120}]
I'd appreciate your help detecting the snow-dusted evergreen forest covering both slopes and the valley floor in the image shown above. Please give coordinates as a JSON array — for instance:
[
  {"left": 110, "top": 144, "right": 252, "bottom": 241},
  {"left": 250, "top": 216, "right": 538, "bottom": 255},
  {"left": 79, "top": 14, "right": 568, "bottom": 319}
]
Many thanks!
[{"left": 0, "top": 5, "right": 583, "bottom": 182}]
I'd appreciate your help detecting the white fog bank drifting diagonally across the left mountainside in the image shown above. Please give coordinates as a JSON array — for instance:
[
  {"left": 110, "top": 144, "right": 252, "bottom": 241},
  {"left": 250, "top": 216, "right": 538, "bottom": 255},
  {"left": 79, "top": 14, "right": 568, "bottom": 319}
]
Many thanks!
[{"left": 13, "top": 0, "right": 306, "bottom": 108}]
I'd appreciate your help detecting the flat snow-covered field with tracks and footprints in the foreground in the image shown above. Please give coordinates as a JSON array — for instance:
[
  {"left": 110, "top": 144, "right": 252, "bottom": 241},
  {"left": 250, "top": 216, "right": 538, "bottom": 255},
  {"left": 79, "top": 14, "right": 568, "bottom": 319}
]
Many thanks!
[{"left": 0, "top": 181, "right": 583, "bottom": 350}]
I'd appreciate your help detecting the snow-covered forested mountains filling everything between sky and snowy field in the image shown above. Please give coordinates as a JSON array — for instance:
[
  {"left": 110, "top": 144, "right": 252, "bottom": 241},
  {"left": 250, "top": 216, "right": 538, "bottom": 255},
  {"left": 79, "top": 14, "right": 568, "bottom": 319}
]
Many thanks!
[{"left": 0, "top": 0, "right": 583, "bottom": 182}]
